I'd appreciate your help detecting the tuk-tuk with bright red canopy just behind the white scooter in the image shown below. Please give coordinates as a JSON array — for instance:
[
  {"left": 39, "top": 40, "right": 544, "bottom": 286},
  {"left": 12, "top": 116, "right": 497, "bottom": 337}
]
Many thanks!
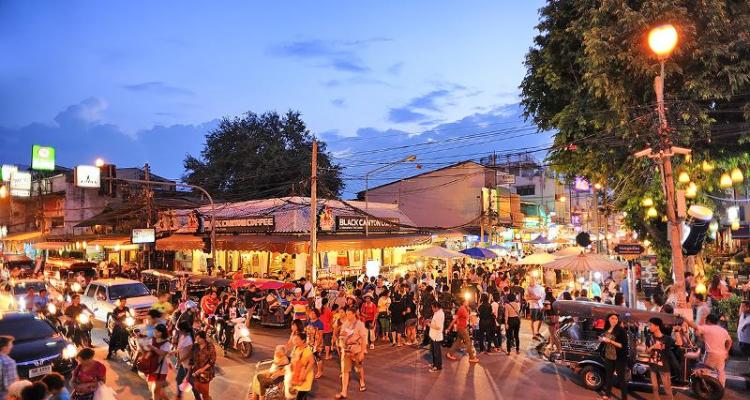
[{"left": 232, "top": 278, "right": 295, "bottom": 327}]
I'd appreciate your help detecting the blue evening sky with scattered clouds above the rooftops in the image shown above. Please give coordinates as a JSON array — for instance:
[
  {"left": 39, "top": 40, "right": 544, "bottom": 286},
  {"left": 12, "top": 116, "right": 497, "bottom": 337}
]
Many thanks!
[{"left": 0, "top": 0, "right": 548, "bottom": 198}]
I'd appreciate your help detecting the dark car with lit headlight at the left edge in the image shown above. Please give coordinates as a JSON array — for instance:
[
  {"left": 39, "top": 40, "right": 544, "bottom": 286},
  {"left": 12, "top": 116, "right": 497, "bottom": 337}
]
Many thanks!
[{"left": 0, "top": 312, "right": 78, "bottom": 380}]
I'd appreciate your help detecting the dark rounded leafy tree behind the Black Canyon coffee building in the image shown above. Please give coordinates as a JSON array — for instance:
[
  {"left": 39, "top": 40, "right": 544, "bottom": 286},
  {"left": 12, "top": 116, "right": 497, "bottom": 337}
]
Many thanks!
[{"left": 183, "top": 111, "right": 343, "bottom": 201}]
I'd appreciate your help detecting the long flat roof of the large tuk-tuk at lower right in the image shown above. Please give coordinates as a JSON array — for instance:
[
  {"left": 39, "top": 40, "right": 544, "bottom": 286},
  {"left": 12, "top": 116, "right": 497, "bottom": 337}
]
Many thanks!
[{"left": 552, "top": 300, "right": 682, "bottom": 326}]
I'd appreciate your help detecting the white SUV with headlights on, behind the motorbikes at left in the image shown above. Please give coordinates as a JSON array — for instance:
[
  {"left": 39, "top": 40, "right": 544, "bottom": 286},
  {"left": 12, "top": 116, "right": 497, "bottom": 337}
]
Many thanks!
[{"left": 81, "top": 278, "right": 158, "bottom": 324}]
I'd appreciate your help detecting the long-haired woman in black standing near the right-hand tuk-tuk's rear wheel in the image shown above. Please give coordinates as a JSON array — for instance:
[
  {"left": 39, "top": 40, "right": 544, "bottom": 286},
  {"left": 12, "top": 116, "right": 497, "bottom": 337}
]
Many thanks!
[{"left": 599, "top": 313, "right": 628, "bottom": 400}]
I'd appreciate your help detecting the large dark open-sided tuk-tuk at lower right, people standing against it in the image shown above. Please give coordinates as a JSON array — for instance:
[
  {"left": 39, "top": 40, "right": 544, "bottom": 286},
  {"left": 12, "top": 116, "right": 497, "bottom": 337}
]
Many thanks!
[{"left": 544, "top": 300, "right": 724, "bottom": 400}]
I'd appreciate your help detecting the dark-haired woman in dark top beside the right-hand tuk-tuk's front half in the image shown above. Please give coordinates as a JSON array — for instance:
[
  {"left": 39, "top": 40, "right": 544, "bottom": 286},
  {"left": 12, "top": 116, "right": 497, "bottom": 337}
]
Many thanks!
[{"left": 647, "top": 318, "right": 677, "bottom": 400}]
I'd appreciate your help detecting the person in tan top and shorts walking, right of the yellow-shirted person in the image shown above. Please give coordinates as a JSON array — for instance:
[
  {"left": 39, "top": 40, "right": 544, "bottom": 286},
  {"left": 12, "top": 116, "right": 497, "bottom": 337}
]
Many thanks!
[{"left": 336, "top": 307, "right": 368, "bottom": 399}]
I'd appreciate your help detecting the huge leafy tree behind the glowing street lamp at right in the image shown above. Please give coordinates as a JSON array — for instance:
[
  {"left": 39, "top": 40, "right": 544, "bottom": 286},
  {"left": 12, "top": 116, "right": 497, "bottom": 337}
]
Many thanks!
[{"left": 521, "top": 0, "right": 750, "bottom": 252}]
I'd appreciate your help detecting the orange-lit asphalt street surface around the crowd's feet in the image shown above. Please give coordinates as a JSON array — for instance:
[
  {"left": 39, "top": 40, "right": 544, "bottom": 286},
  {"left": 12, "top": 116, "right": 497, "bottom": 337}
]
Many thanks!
[{"left": 89, "top": 321, "right": 750, "bottom": 400}]
